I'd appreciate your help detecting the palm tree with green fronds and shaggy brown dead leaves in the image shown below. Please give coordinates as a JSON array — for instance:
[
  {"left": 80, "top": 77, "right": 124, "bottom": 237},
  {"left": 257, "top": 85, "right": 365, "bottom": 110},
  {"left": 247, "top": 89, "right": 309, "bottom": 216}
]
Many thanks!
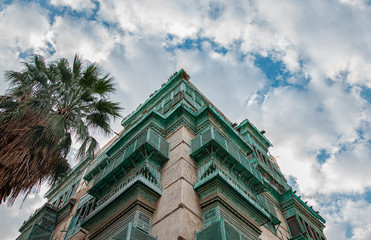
[{"left": 0, "top": 55, "right": 121, "bottom": 204}]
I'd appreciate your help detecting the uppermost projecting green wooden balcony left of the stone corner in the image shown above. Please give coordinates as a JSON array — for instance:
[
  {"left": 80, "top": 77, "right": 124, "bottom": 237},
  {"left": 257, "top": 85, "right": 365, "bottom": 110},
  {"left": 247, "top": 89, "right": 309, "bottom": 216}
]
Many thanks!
[{"left": 84, "top": 129, "right": 170, "bottom": 192}]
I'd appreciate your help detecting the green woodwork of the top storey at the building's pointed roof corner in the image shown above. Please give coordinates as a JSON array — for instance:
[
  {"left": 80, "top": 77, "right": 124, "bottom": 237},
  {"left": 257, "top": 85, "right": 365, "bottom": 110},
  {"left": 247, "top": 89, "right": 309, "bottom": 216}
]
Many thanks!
[{"left": 117, "top": 70, "right": 252, "bottom": 155}]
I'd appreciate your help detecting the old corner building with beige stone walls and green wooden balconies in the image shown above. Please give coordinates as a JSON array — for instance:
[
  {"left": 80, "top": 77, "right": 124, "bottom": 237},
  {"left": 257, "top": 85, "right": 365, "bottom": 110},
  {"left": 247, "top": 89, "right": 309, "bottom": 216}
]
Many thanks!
[{"left": 18, "top": 70, "right": 326, "bottom": 240}]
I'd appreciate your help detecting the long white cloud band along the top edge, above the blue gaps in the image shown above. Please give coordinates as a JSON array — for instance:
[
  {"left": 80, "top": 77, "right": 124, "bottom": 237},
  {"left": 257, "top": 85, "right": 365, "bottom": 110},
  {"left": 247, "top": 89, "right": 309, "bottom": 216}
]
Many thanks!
[{"left": 100, "top": 0, "right": 371, "bottom": 89}]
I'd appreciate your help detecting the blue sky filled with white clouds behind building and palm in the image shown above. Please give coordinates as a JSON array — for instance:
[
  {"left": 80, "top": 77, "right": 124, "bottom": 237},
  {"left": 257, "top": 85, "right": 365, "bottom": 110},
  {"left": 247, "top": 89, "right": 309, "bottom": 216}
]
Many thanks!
[{"left": 0, "top": 0, "right": 371, "bottom": 240}]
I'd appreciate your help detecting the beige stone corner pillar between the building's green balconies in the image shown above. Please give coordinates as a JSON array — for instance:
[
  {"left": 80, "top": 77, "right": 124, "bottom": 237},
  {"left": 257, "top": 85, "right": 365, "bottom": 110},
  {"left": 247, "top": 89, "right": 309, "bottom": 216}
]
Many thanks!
[{"left": 151, "top": 125, "right": 202, "bottom": 240}]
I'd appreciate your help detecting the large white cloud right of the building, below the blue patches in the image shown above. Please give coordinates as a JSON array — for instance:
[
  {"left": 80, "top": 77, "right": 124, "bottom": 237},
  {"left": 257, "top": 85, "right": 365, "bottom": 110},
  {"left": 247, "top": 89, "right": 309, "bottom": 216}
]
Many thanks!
[{"left": 245, "top": 78, "right": 371, "bottom": 194}]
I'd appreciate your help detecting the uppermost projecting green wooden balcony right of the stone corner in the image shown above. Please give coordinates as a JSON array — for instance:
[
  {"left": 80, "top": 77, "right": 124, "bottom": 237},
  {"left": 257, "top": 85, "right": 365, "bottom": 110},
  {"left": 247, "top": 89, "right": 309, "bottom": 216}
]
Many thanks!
[{"left": 190, "top": 126, "right": 265, "bottom": 192}]
